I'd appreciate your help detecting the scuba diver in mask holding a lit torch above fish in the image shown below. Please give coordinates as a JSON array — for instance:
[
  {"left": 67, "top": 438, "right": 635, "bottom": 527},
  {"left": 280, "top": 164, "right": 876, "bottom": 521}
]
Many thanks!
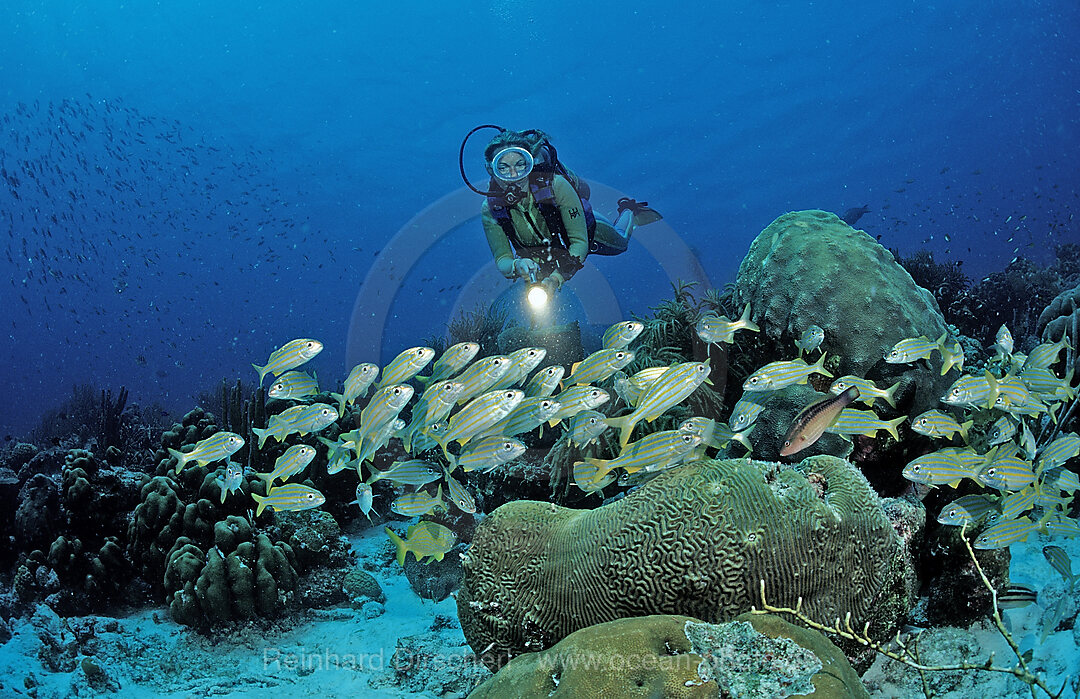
[{"left": 458, "top": 124, "right": 661, "bottom": 293}]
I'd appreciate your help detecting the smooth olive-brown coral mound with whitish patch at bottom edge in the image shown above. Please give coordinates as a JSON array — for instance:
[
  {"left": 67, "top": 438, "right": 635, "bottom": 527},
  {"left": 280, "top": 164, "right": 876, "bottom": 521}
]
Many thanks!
[{"left": 469, "top": 615, "right": 867, "bottom": 699}]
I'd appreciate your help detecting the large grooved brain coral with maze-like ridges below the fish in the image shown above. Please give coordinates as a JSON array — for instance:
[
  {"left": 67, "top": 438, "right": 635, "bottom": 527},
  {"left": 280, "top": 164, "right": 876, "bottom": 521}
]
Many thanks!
[{"left": 457, "top": 456, "right": 914, "bottom": 666}]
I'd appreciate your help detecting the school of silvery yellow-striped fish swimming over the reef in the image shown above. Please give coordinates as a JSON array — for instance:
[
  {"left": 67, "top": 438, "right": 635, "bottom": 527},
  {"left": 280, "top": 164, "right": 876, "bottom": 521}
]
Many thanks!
[{"left": 166, "top": 306, "right": 1080, "bottom": 561}]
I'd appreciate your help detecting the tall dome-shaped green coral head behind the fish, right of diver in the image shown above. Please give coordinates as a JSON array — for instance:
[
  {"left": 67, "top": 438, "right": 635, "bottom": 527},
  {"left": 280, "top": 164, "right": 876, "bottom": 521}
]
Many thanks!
[{"left": 735, "top": 211, "right": 959, "bottom": 412}]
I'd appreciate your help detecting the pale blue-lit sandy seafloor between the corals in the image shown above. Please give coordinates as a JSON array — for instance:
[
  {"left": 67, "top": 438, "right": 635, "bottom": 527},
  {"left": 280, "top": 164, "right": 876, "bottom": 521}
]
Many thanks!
[{"left": 0, "top": 516, "right": 1080, "bottom": 699}]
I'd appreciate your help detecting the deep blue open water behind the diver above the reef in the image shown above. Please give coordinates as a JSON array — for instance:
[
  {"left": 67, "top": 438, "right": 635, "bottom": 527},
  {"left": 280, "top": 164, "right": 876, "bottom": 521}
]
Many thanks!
[{"left": 0, "top": 0, "right": 1080, "bottom": 434}]
